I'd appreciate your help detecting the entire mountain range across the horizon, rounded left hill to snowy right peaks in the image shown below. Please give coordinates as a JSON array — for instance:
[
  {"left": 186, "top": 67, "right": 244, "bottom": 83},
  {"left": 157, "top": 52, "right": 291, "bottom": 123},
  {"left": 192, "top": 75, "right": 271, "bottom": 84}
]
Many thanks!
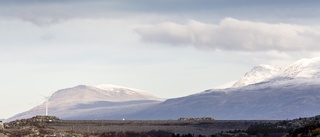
[{"left": 9, "top": 58, "right": 320, "bottom": 120}]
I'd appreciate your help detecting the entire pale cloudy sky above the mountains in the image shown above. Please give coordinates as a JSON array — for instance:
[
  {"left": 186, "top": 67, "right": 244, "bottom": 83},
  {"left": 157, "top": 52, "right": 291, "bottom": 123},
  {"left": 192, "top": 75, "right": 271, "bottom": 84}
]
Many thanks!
[{"left": 0, "top": 0, "right": 320, "bottom": 118}]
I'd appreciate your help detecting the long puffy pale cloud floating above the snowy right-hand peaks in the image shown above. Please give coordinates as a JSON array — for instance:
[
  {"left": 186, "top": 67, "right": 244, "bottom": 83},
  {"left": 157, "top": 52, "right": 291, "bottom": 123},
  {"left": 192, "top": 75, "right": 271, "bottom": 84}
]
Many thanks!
[{"left": 136, "top": 18, "right": 320, "bottom": 52}]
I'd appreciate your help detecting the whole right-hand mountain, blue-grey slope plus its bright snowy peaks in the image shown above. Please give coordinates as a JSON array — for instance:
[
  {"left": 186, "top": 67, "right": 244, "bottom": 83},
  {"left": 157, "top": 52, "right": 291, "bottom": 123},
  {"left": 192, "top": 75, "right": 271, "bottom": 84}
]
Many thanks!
[{"left": 133, "top": 58, "right": 320, "bottom": 119}]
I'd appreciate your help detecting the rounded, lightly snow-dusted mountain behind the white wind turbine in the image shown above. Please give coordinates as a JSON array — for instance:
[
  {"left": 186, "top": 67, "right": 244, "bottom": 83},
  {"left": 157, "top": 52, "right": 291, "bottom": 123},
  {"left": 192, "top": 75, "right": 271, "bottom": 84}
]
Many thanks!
[{"left": 7, "top": 85, "right": 163, "bottom": 121}]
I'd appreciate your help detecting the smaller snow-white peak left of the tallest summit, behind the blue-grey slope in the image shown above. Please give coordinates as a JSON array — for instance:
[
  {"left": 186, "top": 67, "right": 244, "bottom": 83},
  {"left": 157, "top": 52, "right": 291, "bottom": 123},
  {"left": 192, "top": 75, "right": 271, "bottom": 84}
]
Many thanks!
[{"left": 232, "top": 65, "right": 280, "bottom": 88}]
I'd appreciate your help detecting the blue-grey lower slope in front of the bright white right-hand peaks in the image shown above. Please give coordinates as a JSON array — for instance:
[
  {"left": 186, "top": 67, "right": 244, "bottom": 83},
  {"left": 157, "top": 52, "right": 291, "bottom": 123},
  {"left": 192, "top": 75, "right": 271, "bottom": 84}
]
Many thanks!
[{"left": 133, "top": 78, "right": 320, "bottom": 120}]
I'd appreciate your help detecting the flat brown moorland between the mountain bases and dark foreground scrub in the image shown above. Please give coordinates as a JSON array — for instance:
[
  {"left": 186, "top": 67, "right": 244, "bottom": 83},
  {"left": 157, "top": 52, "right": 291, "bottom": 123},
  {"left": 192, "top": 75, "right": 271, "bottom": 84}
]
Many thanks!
[{"left": 48, "top": 120, "right": 277, "bottom": 135}]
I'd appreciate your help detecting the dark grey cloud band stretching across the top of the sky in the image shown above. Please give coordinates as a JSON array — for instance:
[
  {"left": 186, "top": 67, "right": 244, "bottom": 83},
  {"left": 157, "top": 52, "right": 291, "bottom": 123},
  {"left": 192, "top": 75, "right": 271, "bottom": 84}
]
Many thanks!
[{"left": 0, "top": 0, "right": 320, "bottom": 26}]
